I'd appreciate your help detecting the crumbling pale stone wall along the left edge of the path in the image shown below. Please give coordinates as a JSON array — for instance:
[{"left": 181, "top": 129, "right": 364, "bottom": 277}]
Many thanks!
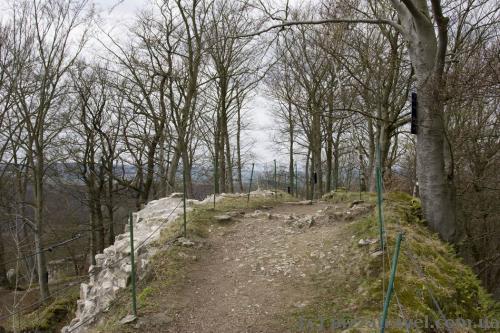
[{"left": 61, "top": 189, "right": 274, "bottom": 333}]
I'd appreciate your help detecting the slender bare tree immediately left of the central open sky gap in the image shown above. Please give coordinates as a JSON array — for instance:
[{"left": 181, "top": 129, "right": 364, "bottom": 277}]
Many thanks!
[{"left": 206, "top": 0, "right": 263, "bottom": 193}]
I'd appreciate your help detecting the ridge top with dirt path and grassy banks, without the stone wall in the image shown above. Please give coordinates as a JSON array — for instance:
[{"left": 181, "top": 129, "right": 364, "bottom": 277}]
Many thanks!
[{"left": 10, "top": 192, "right": 492, "bottom": 332}]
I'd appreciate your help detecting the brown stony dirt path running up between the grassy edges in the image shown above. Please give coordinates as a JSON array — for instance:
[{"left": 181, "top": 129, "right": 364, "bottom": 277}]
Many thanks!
[{"left": 139, "top": 203, "right": 368, "bottom": 333}]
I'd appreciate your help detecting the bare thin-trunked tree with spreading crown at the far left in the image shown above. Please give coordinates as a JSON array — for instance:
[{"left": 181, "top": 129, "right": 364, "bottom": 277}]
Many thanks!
[{"left": 4, "top": 0, "right": 91, "bottom": 300}]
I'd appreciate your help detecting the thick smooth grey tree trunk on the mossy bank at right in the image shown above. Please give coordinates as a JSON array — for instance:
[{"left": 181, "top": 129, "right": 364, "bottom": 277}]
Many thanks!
[{"left": 400, "top": 0, "right": 460, "bottom": 242}]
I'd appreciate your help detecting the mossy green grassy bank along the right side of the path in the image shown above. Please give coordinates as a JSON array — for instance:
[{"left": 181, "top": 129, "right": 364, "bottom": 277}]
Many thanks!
[{"left": 292, "top": 192, "right": 500, "bottom": 332}]
